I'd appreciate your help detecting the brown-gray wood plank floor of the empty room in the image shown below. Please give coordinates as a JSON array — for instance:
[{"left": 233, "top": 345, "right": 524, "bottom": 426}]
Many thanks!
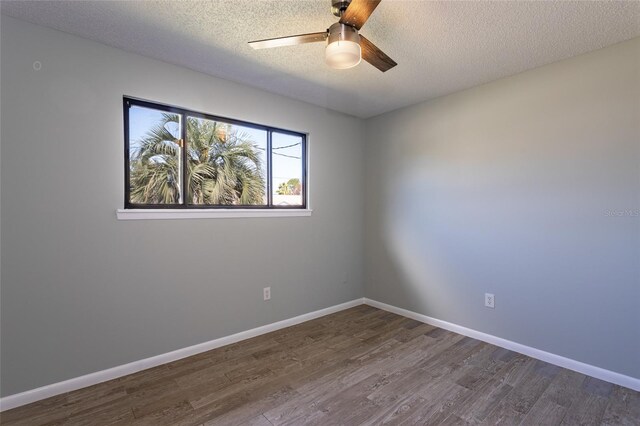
[{"left": 0, "top": 305, "right": 640, "bottom": 426}]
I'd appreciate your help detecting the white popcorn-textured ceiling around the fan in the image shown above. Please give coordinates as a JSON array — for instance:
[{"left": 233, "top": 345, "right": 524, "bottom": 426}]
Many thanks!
[{"left": 1, "top": 0, "right": 640, "bottom": 117}]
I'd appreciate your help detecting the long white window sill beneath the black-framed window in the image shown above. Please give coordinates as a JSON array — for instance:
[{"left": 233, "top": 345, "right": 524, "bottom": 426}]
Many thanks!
[{"left": 116, "top": 209, "right": 313, "bottom": 220}]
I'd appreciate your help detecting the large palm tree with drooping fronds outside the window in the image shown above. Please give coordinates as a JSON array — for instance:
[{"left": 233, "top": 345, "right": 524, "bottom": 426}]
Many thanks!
[{"left": 131, "top": 113, "right": 265, "bottom": 205}]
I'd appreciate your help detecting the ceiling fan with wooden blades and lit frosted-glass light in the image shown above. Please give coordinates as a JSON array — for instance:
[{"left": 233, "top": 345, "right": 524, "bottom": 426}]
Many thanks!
[{"left": 249, "top": 0, "right": 398, "bottom": 72}]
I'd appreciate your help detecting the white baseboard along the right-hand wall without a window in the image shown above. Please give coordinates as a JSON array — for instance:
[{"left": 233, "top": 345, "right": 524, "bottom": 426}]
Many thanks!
[{"left": 364, "top": 297, "right": 640, "bottom": 391}]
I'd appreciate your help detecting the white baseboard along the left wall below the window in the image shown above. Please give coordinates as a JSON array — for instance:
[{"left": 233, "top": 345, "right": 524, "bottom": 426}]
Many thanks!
[{"left": 0, "top": 299, "right": 364, "bottom": 411}]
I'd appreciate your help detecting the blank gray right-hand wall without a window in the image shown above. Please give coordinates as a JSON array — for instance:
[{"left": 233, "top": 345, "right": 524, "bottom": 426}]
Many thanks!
[{"left": 365, "top": 35, "right": 640, "bottom": 377}]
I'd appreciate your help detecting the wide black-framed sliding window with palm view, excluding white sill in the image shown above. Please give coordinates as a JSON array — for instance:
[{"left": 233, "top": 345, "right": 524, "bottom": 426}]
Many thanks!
[{"left": 124, "top": 97, "right": 307, "bottom": 209}]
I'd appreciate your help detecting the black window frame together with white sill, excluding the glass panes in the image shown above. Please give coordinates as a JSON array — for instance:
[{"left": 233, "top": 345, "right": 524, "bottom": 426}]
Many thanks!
[{"left": 124, "top": 96, "right": 311, "bottom": 210}]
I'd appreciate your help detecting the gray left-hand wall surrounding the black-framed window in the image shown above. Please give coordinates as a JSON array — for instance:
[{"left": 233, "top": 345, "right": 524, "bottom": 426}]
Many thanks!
[{"left": 1, "top": 16, "right": 364, "bottom": 395}]
